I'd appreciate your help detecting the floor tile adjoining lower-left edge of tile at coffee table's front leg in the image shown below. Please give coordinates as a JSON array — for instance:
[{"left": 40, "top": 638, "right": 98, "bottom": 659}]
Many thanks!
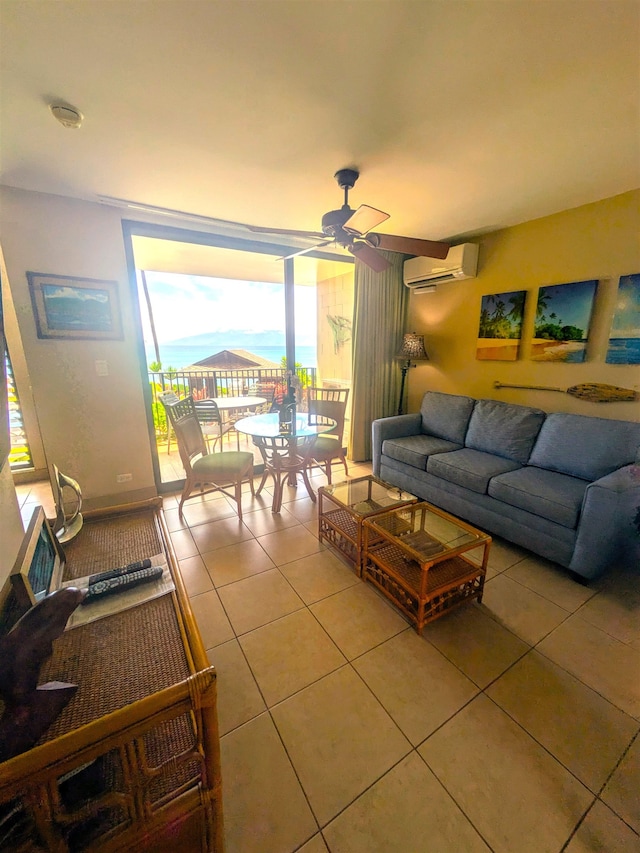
[{"left": 271, "top": 666, "right": 411, "bottom": 826}]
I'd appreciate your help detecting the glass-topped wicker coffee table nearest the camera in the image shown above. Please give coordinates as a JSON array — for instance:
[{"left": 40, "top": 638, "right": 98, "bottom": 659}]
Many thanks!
[{"left": 363, "top": 503, "right": 491, "bottom": 634}]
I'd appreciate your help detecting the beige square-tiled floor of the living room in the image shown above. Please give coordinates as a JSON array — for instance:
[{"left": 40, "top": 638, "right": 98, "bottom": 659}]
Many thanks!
[{"left": 18, "top": 466, "right": 640, "bottom": 853}]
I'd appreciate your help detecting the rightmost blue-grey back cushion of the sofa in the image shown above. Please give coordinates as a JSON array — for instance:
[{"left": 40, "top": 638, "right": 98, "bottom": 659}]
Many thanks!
[{"left": 529, "top": 412, "right": 640, "bottom": 481}]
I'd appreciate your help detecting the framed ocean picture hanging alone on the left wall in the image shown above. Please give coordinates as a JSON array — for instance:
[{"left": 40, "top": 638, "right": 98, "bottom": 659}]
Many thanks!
[{"left": 27, "top": 272, "right": 123, "bottom": 340}]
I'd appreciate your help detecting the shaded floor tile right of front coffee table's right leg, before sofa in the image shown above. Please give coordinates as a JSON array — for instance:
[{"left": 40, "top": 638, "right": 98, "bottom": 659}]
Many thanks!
[{"left": 482, "top": 573, "right": 569, "bottom": 645}]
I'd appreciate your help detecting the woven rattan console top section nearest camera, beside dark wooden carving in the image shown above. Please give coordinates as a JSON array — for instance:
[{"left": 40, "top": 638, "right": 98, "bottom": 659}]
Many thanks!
[{"left": 40, "top": 594, "right": 190, "bottom": 740}]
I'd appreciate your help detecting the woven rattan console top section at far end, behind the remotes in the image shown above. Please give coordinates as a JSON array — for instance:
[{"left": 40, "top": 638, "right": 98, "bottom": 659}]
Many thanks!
[{"left": 63, "top": 509, "right": 163, "bottom": 580}]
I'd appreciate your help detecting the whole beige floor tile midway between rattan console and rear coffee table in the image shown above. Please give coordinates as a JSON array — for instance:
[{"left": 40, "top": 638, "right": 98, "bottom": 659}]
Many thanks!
[{"left": 218, "top": 569, "right": 304, "bottom": 634}]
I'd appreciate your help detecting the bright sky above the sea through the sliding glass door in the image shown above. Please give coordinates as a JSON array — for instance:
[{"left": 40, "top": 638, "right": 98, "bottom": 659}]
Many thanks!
[{"left": 140, "top": 272, "right": 316, "bottom": 345}]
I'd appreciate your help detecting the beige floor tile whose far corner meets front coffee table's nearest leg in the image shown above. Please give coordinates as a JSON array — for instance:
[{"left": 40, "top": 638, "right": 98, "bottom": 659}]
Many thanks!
[{"left": 353, "top": 628, "right": 478, "bottom": 746}]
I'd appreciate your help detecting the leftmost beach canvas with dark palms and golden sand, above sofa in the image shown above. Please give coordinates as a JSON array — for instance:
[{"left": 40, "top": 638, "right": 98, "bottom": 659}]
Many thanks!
[{"left": 476, "top": 290, "right": 527, "bottom": 361}]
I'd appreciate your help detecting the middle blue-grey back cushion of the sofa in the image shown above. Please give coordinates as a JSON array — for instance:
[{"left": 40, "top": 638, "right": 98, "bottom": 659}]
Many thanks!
[{"left": 464, "top": 400, "right": 545, "bottom": 463}]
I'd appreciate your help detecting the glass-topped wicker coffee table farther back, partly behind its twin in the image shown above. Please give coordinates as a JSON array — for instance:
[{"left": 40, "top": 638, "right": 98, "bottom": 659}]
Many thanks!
[{"left": 318, "top": 475, "right": 418, "bottom": 577}]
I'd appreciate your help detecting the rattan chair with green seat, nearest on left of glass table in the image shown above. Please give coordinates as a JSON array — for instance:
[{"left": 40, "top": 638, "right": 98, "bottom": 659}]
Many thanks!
[{"left": 166, "top": 397, "right": 255, "bottom": 520}]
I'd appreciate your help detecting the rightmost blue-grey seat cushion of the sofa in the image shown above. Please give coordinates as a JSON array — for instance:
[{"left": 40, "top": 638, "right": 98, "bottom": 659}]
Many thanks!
[{"left": 489, "top": 465, "right": 589, "bottom": 529}]
